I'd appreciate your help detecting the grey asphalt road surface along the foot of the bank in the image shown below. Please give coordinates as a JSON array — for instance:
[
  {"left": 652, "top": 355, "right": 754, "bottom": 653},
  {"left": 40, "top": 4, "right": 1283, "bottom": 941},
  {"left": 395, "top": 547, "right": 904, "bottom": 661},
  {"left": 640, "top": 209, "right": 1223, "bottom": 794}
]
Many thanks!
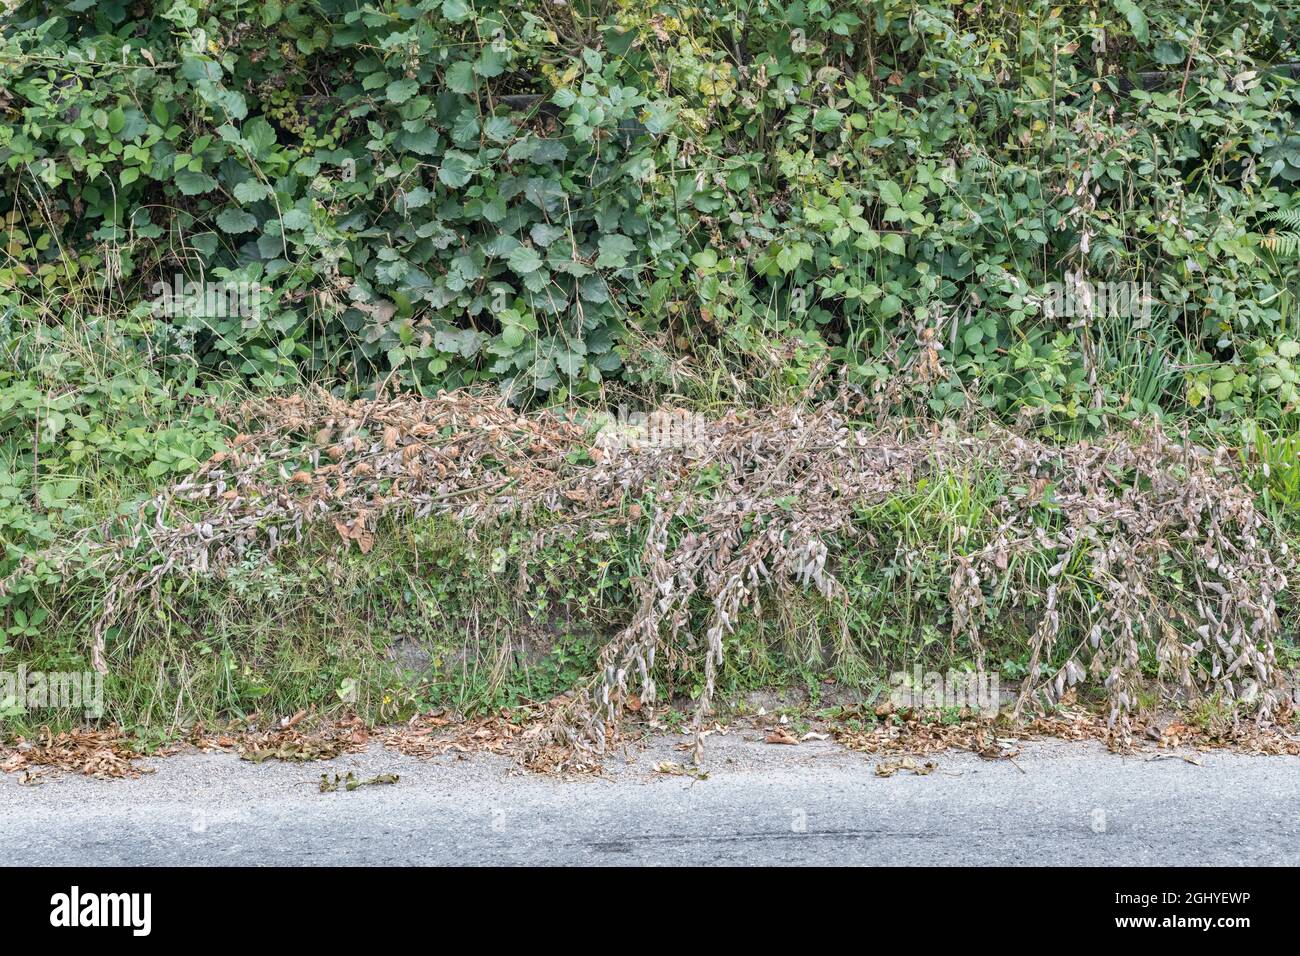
[{"left": 0, "top": 734, "right": 1300, "bottom": 866}]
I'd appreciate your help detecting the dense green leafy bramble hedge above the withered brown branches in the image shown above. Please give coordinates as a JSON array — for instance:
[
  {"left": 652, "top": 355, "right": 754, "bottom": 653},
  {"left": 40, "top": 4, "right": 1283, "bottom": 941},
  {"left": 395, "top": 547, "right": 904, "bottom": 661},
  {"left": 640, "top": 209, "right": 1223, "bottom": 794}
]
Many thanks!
[{"left": 0, "top": 0, "right": 1300, "bottom": 431}]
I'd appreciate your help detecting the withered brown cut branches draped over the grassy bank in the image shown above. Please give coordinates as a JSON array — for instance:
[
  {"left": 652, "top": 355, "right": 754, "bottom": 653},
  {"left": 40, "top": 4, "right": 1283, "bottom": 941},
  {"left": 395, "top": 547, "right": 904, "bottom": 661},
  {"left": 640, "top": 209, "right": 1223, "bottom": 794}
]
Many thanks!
[{"left": 7, "top": 392, "right": 1287, "bottom": 752}]
